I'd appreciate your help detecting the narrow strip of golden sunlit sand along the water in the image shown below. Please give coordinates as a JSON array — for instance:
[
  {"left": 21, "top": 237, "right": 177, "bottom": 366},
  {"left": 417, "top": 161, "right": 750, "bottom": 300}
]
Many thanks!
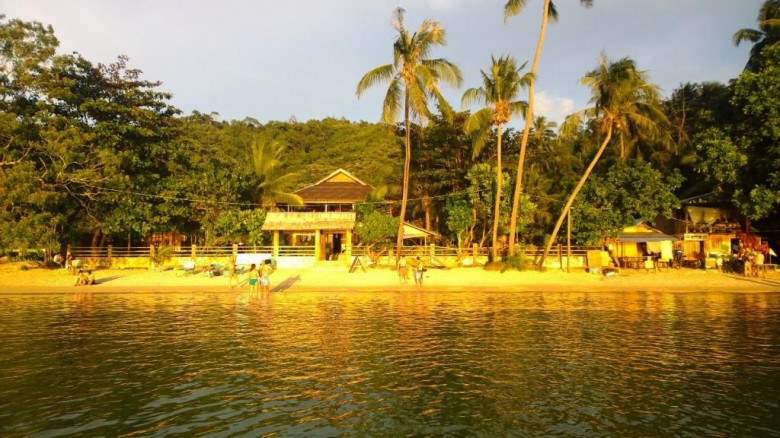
[{"left": 0, "top": 263, "right": 780, "bottom": 294}]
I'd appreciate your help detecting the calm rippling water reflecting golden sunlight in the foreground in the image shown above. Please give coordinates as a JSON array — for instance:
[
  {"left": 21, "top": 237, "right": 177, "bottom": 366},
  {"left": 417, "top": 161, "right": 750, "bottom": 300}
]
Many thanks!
[{"left": 0, "top": 291, "right": 780, "bottom": 437}]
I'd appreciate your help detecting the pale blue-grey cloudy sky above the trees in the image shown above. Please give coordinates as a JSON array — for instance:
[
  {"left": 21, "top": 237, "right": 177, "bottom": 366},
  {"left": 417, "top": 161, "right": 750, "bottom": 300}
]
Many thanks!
[{"left": 0, "top": 0, "right": 763, "bottom": 128}]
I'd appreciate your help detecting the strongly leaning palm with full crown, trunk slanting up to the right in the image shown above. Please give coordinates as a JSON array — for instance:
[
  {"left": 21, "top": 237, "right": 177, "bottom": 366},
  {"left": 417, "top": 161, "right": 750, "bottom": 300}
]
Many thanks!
[{"left": 539, "top": 54, "right": 662, "bottom": 267}]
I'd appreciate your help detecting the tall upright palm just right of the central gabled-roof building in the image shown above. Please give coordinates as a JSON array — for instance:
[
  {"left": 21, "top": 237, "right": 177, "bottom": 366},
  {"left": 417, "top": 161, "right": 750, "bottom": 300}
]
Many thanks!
[{"left": 356, "top": 8, "right": 463, "bottom": 262}]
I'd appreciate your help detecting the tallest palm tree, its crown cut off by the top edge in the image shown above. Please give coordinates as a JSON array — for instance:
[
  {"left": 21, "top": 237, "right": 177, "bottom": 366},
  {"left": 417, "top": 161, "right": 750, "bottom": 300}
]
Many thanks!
[{"left": 504, "top": 0, "right": 593, "bottom": 256}]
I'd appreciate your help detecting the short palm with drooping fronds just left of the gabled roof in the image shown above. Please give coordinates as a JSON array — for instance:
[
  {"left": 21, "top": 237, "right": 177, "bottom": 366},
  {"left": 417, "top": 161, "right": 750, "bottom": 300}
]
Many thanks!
[{"left": 251, "top": 139, "right": 303, "bottom": 210}]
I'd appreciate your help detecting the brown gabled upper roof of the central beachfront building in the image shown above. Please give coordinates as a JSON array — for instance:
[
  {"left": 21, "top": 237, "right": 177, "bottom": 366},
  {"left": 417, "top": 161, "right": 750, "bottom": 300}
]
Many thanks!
[{"left": 295, "top": 169, "right": 374, "bottom": 204}]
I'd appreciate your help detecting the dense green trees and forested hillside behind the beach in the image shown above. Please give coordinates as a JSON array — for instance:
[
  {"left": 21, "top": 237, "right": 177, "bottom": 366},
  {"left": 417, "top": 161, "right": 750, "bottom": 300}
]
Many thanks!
[{"left": 0, "top": 0, "right": 780, "bottom": 252}]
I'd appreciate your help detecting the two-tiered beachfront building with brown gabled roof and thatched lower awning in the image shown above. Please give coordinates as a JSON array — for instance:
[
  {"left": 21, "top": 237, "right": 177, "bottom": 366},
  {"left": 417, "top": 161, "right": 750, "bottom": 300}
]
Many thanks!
[{"left": 263, "top": 169, "right": 374, "bottom": 263}]
